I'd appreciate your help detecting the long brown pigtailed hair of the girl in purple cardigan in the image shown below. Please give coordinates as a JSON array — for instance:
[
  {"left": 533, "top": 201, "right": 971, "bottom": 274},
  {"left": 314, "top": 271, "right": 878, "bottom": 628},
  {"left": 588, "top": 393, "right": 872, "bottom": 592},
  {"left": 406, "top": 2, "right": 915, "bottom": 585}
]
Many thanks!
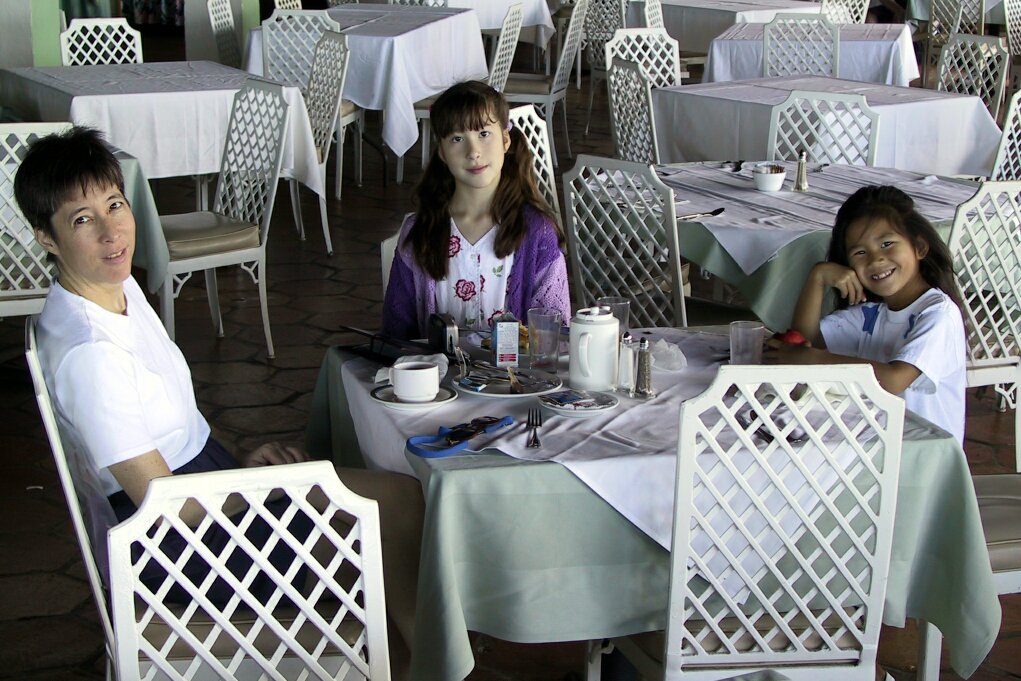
[{"left": 408, "top": 81, "right": 564, "bottom": 280}]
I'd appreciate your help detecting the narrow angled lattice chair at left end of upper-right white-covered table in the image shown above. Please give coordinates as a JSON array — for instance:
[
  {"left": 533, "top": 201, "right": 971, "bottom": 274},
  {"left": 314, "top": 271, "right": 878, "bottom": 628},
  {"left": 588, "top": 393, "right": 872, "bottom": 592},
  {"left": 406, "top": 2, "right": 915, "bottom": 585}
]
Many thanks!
[{"left": 606, "top": 58, "right": 660, "bottom": 165}]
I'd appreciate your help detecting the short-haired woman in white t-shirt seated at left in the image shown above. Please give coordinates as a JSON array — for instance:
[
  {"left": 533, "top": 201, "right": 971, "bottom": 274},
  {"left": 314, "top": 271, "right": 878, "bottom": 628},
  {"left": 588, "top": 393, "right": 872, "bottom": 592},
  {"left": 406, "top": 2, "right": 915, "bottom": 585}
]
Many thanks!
[{"left": 14, "top": 128, "right": 424, "bottom": 673}]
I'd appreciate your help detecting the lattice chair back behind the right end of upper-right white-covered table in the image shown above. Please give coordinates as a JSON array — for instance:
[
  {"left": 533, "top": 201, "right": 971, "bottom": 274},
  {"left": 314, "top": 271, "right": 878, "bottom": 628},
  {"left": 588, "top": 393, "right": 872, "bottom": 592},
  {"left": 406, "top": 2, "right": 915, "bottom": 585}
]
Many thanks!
[{"left": 936, "top": 34, "right": 1011, "bottom": 120}]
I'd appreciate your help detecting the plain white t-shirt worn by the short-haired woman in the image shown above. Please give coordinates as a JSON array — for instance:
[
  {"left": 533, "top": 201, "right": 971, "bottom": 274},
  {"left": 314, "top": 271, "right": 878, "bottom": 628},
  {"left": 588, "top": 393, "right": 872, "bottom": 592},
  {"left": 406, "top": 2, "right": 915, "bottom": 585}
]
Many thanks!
[{"left": 38, "top": 277, "right": 209, "bottom": 495}]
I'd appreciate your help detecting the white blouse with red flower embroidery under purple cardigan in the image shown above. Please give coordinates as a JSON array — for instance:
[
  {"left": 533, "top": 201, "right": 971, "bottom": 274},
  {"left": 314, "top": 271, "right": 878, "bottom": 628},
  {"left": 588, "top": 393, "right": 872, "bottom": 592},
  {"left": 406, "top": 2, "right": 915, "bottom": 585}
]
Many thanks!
[{"left": 436, "top": 220, "right": 514, "bottom": 329}]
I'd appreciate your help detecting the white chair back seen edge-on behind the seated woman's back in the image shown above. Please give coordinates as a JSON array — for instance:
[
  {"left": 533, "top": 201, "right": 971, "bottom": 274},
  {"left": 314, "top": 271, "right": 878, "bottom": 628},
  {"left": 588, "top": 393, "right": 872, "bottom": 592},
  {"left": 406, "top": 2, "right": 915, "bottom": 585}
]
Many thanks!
[{"left": 25, "top": 317, "right": 117, "bottom": 679}]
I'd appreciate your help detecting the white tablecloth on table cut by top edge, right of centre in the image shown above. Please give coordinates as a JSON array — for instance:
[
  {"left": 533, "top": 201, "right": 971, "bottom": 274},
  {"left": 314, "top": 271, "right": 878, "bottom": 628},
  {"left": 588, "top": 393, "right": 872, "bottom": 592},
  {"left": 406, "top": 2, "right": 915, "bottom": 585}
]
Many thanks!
[{"left": 627, "top": 0, "right": 819, "bottom": 52}]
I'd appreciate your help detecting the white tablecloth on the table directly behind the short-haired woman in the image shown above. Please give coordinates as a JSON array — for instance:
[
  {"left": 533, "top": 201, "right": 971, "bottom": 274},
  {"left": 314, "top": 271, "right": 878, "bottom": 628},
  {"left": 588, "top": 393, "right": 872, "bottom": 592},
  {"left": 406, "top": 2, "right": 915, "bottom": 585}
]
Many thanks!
[{"left": 0, "top": 61, "right": 325, "bottom": 195}]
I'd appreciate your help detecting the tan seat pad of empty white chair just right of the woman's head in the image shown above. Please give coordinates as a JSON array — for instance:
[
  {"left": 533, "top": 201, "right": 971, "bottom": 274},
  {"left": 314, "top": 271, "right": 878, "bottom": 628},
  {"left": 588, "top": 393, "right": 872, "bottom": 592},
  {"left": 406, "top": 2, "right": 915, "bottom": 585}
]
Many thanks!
[{"left": 159, "top": 211, "right": 259, "bottom": 260}]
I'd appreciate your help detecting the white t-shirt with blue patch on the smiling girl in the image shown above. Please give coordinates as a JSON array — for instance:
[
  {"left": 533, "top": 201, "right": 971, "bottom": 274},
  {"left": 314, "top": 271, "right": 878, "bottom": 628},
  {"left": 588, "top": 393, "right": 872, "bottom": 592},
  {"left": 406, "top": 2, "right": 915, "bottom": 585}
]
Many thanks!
[{"left": 819, "top": 289, "right": 968, "bottom": 442}]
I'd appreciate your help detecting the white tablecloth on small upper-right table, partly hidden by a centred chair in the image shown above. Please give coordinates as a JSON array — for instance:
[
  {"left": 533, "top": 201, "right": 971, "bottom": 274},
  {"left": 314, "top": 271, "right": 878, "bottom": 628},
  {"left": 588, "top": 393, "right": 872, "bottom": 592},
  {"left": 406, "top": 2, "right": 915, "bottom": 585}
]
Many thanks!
[{"left": 702, "top": 23, "right": 918, "bottom": 86}]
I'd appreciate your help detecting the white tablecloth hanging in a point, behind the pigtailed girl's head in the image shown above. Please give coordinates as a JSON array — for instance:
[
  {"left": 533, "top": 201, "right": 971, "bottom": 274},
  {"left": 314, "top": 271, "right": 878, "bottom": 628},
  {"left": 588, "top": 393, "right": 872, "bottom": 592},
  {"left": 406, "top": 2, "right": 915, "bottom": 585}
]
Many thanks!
[{"left": 245, "top": 4, "right": 488, "bottom": 155}]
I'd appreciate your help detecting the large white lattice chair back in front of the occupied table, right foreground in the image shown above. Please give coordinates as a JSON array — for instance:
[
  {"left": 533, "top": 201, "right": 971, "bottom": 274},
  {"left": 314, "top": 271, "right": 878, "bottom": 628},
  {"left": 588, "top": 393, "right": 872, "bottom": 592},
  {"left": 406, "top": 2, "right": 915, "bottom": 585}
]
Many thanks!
[{"left": 664, "top": 364, "right": 904, "bottom": 681}]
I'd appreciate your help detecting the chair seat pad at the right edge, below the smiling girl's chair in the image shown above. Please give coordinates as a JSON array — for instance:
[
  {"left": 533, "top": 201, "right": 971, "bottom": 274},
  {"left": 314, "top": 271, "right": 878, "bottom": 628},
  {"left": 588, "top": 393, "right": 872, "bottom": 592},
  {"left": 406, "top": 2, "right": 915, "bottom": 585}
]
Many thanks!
[{"left": 973, "top": 474, "right": 1021, "bottom": 572}]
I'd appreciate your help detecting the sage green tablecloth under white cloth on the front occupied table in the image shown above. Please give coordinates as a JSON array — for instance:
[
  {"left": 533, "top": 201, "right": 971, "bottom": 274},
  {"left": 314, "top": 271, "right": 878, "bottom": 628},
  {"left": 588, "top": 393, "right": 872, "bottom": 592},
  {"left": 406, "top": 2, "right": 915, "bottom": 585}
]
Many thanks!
[{"left": 307, "top": 348, "right": 1000, "bottom": 681}]
